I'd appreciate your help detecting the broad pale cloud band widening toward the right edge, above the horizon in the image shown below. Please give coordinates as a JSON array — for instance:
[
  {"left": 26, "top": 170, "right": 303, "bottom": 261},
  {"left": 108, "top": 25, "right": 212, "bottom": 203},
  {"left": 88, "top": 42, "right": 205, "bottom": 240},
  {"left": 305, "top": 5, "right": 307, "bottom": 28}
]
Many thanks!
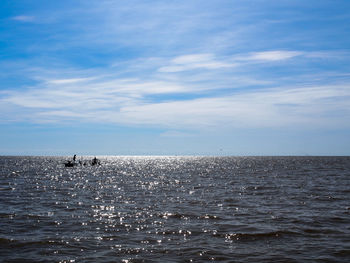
[{"left": 117, "top": 86, "right": 350, "bottom": 128}]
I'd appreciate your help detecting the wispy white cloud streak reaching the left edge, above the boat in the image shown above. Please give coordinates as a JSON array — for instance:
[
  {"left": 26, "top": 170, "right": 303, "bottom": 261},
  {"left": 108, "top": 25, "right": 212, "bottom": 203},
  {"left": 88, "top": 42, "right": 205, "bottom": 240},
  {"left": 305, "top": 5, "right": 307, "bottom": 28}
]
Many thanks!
[{"left": 1, "top": 76, "right": 194, "bottom": 116}]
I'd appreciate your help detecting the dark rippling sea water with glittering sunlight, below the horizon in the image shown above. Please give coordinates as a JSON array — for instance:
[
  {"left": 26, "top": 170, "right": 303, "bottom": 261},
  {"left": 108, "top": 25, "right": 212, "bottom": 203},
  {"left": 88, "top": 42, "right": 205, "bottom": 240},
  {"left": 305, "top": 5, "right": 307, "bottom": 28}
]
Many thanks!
[{"left": 0, "top": 157, "right": 350, "bottom": 262}]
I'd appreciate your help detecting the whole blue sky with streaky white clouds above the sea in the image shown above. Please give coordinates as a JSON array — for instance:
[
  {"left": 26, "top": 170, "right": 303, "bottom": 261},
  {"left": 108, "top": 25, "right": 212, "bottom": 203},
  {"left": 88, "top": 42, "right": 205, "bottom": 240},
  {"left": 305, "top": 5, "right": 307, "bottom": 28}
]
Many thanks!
[{"left": 0, "top": 0, "right": 350, "bottom": 156}]
